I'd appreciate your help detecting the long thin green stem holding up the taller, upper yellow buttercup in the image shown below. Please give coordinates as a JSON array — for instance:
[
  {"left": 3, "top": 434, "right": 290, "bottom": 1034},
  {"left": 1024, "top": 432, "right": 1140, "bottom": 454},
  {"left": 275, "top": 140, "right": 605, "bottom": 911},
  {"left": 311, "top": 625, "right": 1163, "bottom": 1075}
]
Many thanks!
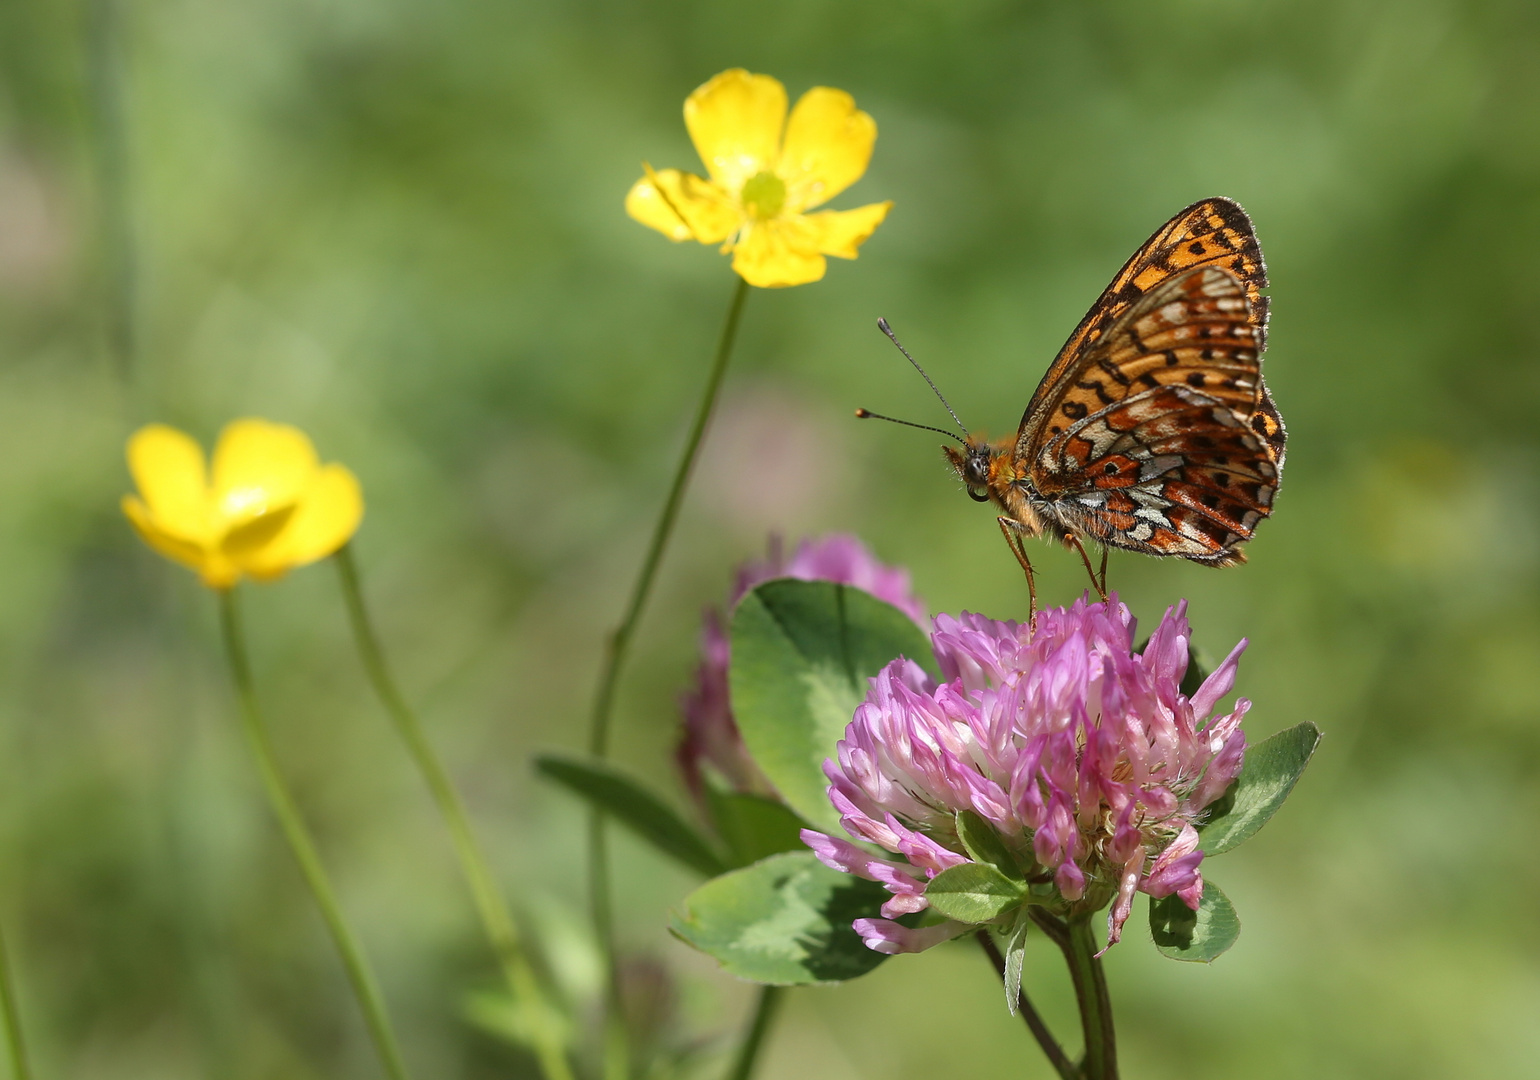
[{"left": 588, "top": 277, "right": 748, "bottom": 1080}]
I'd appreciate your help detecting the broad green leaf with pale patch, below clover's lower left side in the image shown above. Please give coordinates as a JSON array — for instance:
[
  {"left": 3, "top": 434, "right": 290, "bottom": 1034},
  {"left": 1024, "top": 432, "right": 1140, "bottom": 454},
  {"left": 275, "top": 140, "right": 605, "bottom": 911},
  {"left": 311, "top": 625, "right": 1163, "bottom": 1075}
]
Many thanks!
[{"left": 668, "top": 852, "right": 887, "bottom": 986}]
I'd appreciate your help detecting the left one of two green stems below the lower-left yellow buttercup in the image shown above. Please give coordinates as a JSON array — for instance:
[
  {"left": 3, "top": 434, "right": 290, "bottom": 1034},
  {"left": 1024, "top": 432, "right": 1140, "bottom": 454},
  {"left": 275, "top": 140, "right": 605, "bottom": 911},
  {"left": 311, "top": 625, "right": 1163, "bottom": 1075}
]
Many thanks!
[{"left": 219, "top": 589, "right": 408, "bottom": 1080}]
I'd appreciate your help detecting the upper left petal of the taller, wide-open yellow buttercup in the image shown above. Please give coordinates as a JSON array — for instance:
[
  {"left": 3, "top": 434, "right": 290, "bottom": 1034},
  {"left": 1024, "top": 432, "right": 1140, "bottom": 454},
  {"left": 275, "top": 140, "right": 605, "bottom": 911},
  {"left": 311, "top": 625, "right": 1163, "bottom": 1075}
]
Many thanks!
[{"left": 684, "top": 68, "right": 785, "bottom": 194}]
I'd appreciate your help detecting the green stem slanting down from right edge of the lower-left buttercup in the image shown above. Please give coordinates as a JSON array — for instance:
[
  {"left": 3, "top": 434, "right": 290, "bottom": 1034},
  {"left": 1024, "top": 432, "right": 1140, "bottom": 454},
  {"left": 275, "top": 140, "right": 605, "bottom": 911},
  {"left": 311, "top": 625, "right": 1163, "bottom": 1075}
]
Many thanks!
[{"left": 336, "top": 544, "right": 573, "bottom": 1080}]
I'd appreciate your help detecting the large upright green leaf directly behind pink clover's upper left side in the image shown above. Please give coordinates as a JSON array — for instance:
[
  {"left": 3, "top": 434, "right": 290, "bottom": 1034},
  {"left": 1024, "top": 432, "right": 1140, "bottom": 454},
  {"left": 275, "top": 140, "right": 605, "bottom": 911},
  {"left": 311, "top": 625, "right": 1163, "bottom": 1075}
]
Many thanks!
[{"left": 730, "top": 579, "right": 936, "bottom": 832}]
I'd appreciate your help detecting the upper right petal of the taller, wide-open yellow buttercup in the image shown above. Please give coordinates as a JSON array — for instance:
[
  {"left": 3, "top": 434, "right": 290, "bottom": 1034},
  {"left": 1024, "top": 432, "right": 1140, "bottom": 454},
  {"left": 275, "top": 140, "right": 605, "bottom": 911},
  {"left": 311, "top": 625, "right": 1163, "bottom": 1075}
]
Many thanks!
[{"left": 776, "top": 86, "right": 876, "bottom": 213}]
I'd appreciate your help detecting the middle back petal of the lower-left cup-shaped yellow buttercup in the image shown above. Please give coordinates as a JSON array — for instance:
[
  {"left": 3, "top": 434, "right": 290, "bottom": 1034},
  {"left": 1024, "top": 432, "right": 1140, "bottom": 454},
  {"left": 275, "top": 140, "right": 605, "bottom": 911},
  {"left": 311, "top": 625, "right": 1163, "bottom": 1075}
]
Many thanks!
[{"left": 214, "top": 419, "right": 320, "bottom": 527}]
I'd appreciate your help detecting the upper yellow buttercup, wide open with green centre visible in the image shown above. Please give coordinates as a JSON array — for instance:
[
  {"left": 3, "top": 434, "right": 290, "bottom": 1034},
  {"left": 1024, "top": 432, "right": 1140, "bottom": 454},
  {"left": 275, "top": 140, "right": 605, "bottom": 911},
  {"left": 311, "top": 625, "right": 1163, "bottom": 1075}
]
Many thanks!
[{"left": 625, "top": 68, "right": 893, "bottom": 288}]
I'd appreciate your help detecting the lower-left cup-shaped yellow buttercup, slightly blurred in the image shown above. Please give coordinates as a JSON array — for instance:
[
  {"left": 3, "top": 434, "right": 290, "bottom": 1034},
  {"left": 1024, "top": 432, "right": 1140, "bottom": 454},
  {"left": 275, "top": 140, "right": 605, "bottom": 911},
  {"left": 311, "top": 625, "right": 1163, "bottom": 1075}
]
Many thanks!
[{"left": 123, "top": 419, "right": 363, "bottom": 589}]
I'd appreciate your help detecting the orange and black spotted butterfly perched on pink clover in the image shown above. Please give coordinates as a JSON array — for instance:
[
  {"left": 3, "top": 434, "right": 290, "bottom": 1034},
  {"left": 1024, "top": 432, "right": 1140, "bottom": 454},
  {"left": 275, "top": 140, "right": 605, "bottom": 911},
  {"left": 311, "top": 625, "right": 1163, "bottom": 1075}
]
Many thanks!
[{"left": 861, "top": 199, "right": 1286, "bottom": 610}]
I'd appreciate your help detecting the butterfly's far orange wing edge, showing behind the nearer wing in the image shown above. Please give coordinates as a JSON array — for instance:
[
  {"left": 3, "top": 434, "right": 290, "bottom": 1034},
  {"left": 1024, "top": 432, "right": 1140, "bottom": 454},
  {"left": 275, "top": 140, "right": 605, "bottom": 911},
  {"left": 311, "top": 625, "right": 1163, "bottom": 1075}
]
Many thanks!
[{"left": 1016, "top": 197, "right": 1283, "bottom": 446}]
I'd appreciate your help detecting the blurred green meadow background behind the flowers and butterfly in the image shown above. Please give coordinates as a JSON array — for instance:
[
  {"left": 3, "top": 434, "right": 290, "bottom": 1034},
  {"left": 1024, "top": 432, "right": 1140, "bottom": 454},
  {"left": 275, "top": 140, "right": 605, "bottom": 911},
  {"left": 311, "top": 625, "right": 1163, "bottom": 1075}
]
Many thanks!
[{"left": 0, "top": 0, "right": 1540, "bottom": 1080}]
